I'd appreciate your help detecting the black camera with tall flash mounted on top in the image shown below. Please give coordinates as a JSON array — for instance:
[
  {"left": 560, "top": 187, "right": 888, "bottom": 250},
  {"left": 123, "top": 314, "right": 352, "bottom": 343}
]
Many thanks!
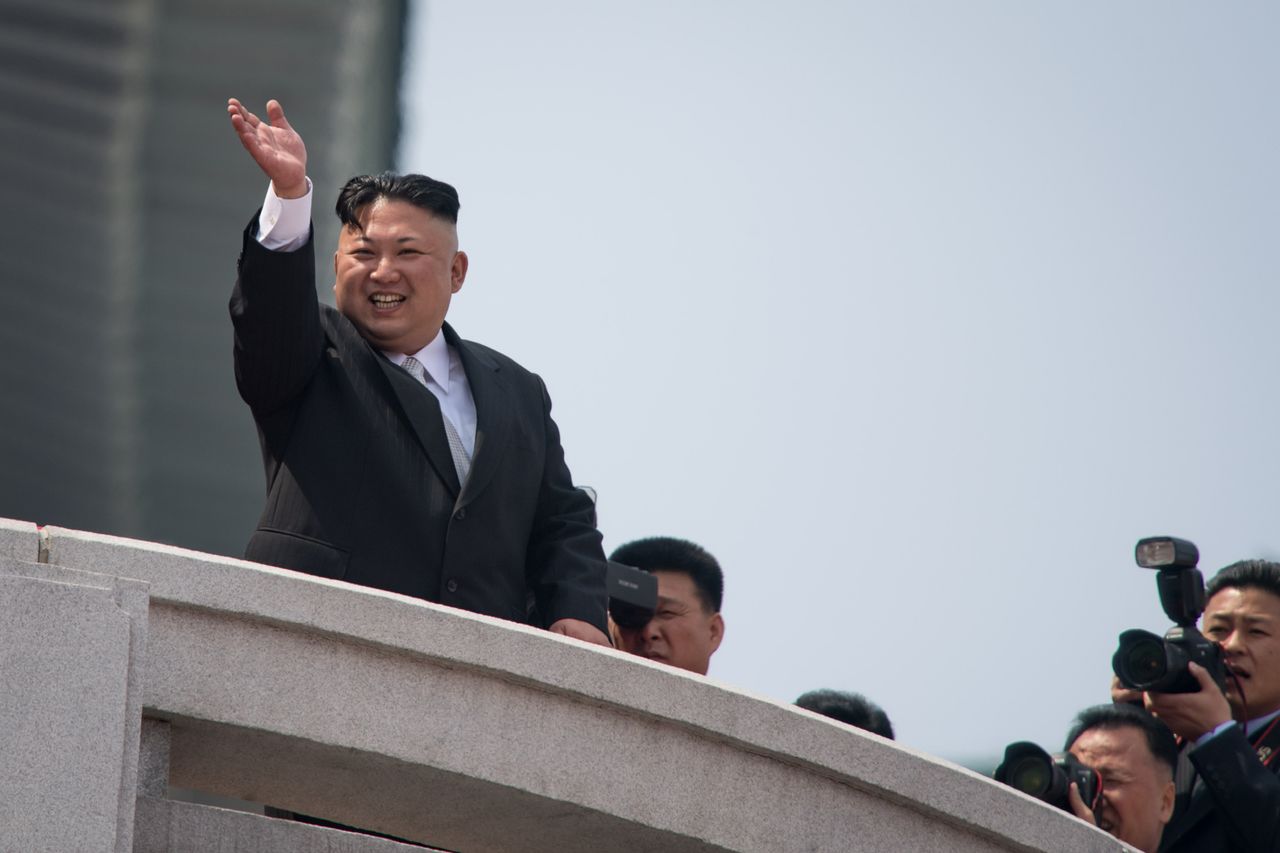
[{"left": 1111, "top": 537, "right": 1226, "bottom": 693}]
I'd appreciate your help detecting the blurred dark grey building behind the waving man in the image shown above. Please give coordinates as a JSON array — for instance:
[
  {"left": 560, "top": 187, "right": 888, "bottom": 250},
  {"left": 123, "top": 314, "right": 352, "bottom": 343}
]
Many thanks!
[{"left": 0, "top": 0, "right": 407, "bottom": 555}]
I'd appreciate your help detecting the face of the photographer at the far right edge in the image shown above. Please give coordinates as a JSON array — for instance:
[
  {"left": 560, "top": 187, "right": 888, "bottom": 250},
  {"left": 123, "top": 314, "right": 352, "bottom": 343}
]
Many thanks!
[{"left": 1202, "top": 587, "right": 1280, "bottom": 721}]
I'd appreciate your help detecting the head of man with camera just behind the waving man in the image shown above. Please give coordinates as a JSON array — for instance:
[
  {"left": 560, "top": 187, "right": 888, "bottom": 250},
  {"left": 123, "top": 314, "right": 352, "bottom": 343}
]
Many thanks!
[{"left": 609, "top": 537, "right": 724, "bottom": 675}]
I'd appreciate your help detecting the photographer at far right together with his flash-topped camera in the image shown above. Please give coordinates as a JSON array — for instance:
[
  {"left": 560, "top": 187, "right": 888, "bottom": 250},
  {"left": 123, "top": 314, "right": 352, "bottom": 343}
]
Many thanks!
[{"left": 1115, "top": 548, "right": 1280, "bottom": 853}]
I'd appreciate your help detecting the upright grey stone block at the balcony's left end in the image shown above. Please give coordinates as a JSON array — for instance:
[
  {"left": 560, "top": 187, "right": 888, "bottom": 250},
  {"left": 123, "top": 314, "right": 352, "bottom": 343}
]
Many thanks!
[{"left": 0, "top": 557, "right": 147, "bottom": 853}]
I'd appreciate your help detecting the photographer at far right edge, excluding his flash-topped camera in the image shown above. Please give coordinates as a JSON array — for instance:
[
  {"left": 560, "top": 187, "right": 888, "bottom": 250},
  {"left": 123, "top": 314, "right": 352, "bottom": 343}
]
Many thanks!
[{"left": 1144, "top": 560, "right": 1280, "bottom": 853}]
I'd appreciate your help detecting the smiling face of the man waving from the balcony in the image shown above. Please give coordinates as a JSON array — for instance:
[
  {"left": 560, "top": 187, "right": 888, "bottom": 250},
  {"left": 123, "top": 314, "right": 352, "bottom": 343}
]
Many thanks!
[{"left": 333, "top": 199, "right": 467, "bottom": 353}]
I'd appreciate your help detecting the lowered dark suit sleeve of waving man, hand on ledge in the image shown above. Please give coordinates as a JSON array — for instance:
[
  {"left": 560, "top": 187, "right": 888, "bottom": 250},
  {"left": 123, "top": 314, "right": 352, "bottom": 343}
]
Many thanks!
[{"left": 525, "top": 378, "right": 608, "bottom": 634}]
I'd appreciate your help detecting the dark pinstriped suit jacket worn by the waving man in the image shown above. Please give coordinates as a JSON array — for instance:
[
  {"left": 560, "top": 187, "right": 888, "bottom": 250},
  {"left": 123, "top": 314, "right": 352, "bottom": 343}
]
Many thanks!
[{"left": 230, "top": 215, "right": 607, "bottom": 630}]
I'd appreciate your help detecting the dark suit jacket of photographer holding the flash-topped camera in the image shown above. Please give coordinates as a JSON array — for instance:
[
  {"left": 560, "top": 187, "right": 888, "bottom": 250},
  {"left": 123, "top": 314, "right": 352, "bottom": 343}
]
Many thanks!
[{"left": 1160, "top": 726, "right": 1280, "bottom": 853}]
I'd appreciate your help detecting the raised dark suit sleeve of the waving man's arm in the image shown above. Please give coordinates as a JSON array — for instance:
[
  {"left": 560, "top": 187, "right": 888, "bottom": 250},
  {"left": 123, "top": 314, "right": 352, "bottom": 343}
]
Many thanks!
[{"left": 230, "top": 213, "right": 324, "bottom": 415}]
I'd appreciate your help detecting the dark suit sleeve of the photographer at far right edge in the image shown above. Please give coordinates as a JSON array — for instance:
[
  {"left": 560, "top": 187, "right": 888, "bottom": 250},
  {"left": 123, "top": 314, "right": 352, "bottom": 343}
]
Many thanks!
[{"left": 1190, "top": 726, "right": 1280, "bottom": 853}]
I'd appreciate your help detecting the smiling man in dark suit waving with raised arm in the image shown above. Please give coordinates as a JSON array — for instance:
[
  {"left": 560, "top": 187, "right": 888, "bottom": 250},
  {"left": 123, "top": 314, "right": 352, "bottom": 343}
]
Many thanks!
[{"left": 228, "top": 99, "right": 608, "bottom": 644}]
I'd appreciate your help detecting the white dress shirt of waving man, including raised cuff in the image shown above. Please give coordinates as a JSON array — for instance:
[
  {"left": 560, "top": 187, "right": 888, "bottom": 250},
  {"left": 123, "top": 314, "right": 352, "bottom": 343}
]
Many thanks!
[{"left": 257, "top": 178, "right": 476, "bottom": 457}]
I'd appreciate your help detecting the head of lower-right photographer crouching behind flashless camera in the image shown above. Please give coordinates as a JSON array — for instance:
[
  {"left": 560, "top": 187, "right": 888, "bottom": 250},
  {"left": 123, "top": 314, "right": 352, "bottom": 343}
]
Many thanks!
[{"left": 1064, "top": 704, "right": 1178, "bottom": 853}]
